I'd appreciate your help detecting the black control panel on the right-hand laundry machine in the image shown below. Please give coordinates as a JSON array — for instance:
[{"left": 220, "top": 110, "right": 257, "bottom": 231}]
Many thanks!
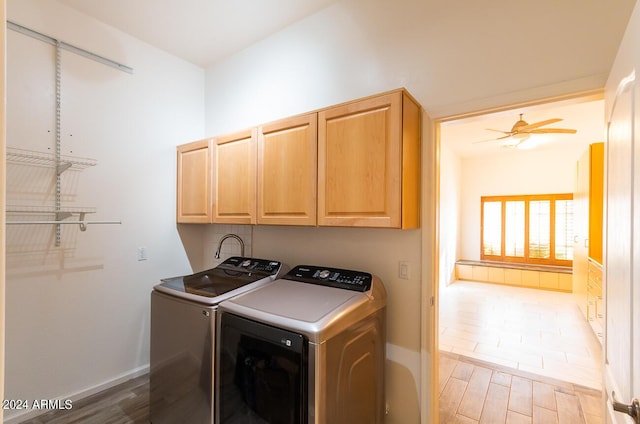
[{"left": 282, "top": 265, "right": 373, "bottom": 292}]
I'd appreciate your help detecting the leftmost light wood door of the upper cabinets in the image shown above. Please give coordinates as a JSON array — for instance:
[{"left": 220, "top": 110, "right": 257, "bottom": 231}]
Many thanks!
[{"left": 176, "top": 140, "right": 211, "bottom": 224}]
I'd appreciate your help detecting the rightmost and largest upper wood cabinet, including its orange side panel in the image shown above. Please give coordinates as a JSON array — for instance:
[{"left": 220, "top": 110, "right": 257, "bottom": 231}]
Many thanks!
[{"left": 318, "top": 90, "right": 420, "bottom": 228}]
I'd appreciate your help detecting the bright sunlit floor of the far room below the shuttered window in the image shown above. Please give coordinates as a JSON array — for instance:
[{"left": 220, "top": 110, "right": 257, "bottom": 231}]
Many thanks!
[{"left": 439, "top": 281, "right": 602, "bottom": 390}]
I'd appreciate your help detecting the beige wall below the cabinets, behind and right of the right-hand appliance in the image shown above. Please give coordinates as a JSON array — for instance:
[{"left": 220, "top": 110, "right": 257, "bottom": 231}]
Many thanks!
[{"left": 253, "top": 226, "right": 422, "bottom": 423}]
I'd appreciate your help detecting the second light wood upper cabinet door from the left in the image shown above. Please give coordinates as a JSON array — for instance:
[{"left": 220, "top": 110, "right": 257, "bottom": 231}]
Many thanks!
[{"left": 213, "top": 129, "right": 257, "bottom": 224}]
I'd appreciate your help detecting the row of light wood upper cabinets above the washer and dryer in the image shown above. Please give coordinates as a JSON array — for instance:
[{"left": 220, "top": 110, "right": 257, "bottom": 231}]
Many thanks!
[{"left": 177, "top": 89, "right": 421, "bottom": 228}]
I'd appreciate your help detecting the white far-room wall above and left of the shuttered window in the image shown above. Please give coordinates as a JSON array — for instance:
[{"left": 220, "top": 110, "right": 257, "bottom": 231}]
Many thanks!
[{"left": 458, "top": 146, "right": 595, "bottom": 260}]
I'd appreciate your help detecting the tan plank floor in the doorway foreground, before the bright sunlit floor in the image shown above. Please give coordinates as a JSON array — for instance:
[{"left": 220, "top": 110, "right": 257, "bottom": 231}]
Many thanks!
[{"left": 439, "top": 351, "right": 602, "bottom": 424}]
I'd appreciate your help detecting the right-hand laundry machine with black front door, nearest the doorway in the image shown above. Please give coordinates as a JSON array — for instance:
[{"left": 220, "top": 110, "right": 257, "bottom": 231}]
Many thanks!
[{"left": 216, "top": 265, "right": 386, "bottom": 424}]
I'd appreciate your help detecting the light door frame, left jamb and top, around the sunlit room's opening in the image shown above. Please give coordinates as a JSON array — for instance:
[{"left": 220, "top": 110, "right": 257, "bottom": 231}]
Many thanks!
[{"left": 421, "top": 87, "right": 605, "bottom": 424}]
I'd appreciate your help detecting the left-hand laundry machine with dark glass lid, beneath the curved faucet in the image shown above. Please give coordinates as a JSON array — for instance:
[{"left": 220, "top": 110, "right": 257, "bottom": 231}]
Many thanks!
[{"left": 149, "top": 257, "right": 282, "bottom": 424}]
